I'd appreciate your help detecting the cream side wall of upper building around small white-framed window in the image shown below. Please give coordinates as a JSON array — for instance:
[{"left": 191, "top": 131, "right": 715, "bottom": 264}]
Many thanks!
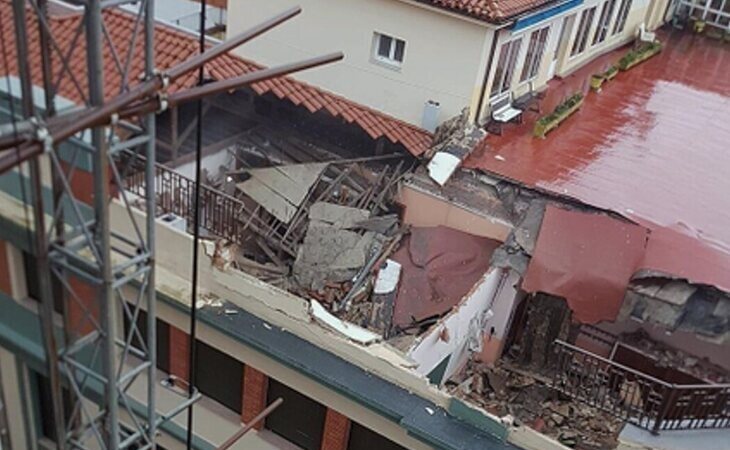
[{"left": 228, "top": 0, "right": 493, "bottom": 126}]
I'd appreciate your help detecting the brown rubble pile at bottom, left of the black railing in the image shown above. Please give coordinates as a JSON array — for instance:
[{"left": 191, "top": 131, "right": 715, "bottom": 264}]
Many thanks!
[{"left": 446, "top": 361, "right": 622, "bottom": 450}]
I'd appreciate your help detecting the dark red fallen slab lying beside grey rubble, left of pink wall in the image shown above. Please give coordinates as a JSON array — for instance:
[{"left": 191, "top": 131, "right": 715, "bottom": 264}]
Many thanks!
[{"left": 393, "top": 226, "right": 501, "bottom": 326}]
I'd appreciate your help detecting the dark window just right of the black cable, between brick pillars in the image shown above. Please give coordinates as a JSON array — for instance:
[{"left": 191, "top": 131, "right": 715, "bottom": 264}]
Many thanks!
[{"left": 195, "top": 341, "right": 243, "bottom": 414}]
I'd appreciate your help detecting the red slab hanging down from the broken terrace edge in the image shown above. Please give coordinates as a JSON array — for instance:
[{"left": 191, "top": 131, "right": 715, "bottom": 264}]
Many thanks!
[{"left": 522, "top": 205, "right": 648, "bottom": 323}]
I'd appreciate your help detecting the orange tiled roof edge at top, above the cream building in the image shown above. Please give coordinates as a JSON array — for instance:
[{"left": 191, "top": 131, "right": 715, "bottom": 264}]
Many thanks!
[{"left": 419, "top": 0, "right": 555, "bottom": 22}]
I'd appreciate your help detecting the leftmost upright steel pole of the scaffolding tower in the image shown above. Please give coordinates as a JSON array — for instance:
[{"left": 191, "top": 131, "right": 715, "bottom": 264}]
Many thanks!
[{"left": 11, "top": 0, "right": 66, "bottom": 450}]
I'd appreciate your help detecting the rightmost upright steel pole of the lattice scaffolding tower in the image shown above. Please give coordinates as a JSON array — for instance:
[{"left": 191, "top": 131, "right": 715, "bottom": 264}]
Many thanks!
[{"left": 144, "top": 0, "right": 157, "bottom": 442}]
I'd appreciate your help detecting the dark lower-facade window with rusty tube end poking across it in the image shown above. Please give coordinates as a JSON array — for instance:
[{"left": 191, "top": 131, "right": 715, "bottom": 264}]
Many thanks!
[{"left": 266, "top": 378, "right": 324, "bottom": 450}]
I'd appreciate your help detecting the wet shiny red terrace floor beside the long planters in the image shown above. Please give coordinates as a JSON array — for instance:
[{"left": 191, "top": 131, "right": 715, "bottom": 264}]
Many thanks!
[{"left": 465, "top": 32, "right": 730, "bottom": 291}]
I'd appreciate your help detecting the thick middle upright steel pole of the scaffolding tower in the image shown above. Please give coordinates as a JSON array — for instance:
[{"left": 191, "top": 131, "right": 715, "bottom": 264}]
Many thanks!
[{"left": 84, "top": 0, "right": 120, "bottom": 450}]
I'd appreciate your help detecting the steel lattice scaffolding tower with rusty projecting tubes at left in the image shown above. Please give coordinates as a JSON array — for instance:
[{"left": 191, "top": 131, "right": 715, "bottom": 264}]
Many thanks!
[{"left": 0, "top": 0, "right": 342, "bottom": 450}]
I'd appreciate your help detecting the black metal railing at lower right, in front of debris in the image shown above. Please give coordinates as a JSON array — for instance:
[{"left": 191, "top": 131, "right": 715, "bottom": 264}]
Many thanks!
[{"left": 552, "top": 340, "right": 730, "bottom": 433}]
